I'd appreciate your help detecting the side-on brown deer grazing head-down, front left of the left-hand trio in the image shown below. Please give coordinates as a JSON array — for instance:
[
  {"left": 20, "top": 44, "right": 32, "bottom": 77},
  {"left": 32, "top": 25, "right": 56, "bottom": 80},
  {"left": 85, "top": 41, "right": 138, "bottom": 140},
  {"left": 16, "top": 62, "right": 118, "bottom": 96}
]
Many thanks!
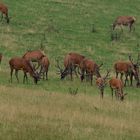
[{"left": 9, "top": 57, "right": 40, "bottom": 84}]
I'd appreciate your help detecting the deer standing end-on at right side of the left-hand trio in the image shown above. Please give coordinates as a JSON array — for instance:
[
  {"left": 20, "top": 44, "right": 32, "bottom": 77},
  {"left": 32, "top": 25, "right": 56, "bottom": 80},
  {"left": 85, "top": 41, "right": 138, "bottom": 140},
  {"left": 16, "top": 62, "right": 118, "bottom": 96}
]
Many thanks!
[{"left": 40, "top": 56, "right": 50, "bottom": 80}]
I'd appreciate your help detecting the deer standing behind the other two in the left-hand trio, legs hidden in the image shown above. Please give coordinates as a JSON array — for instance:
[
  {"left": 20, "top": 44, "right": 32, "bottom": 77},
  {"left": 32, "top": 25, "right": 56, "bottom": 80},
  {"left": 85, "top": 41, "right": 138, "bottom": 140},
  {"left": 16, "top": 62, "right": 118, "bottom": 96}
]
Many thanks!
[{"left": 23, "top": 50, "right": 45, "bottom": 67}]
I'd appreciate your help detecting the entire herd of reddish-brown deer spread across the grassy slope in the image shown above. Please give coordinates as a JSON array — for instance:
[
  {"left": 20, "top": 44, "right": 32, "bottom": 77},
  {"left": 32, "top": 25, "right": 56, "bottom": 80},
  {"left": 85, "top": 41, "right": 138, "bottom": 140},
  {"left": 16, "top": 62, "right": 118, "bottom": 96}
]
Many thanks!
[{"left": 0, "top": 3, "right": 140, "bottom": 100}]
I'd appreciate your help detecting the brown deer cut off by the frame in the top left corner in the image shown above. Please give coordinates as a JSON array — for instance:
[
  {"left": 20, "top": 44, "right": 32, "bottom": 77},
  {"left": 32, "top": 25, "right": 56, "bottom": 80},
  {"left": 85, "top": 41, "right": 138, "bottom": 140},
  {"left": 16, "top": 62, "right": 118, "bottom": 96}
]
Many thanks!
[{"left": 0, "top": 3, "right": 10, "bottom": 23}]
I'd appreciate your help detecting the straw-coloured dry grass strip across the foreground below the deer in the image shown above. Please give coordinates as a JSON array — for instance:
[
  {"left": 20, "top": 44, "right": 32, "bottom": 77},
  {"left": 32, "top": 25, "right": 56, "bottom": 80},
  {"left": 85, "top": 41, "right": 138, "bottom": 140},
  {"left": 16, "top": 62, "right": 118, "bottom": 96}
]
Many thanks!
[{"left": 0, "top": 86, "right": 140, "bottom": 140}]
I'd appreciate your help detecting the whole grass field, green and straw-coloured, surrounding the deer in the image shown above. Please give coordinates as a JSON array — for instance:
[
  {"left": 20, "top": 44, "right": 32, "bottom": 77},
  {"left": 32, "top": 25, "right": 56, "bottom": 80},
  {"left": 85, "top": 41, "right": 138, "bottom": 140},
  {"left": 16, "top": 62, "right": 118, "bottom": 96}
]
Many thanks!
[{"left": 0, "top": 0, "right": 140, "bottom": 140}]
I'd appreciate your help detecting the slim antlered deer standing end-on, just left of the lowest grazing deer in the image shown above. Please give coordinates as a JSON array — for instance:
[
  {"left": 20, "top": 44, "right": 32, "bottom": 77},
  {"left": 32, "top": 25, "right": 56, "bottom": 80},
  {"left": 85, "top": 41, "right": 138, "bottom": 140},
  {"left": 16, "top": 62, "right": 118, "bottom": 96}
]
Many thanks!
[{"left": 96, "top": 71, "right": 110, "bottom": 99}]
